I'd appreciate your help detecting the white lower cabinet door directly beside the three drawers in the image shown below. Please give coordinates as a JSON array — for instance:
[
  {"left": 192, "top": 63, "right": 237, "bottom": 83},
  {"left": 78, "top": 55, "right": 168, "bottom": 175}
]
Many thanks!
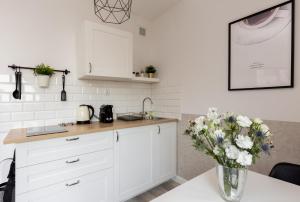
[{"left": 115, "top": 126, "right": 153, "bottom": 201}]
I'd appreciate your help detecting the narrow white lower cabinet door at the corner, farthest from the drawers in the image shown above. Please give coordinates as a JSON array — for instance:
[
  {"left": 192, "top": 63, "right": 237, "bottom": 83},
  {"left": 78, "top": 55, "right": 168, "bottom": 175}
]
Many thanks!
[{"left": 153, "top": 123, "right": 177, "bottom": 184}]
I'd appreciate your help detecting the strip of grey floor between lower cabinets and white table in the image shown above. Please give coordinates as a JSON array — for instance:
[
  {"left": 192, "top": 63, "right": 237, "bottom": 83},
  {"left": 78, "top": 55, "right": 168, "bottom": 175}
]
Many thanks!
[{"left": 126, "top": 180, "right": 179, "bottom": 202}]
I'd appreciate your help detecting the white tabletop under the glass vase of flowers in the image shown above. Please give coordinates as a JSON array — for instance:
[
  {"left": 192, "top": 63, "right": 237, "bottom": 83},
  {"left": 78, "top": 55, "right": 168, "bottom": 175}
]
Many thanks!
[{"left": 152, "top": 169, "right": 300, "bottom": 202}]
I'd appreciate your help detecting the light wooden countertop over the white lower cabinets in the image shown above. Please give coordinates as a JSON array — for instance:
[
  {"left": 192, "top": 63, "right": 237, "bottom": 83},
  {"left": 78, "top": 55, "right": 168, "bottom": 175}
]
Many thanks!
[{"left": 3, "top": 119, "right": 177, "bottom": 144}]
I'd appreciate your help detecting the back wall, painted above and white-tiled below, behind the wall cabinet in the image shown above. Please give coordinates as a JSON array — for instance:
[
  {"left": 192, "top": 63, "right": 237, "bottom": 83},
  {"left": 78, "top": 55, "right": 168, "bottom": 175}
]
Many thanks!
[{"left": 0, "top": 0, "right": 158, "bottom": 182}]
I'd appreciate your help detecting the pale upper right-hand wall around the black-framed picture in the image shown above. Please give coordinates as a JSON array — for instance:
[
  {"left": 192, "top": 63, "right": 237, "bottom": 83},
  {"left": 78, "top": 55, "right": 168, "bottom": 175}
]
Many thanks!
[{"left": 151, "top": 0, "right": 300, "bottom": 122}]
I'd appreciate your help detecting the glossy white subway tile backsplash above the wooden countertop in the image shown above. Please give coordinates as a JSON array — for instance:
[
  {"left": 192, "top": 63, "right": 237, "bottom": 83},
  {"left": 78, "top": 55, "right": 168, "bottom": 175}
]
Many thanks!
[{"left": 0, "top": 74, "right": 180, "bottom": 129}]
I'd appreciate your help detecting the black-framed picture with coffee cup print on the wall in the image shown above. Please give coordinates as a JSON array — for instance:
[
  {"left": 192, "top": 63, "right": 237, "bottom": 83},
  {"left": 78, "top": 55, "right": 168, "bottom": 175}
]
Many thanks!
[{"left": 228, "top": 0, "right": 295, "bottom": 91}]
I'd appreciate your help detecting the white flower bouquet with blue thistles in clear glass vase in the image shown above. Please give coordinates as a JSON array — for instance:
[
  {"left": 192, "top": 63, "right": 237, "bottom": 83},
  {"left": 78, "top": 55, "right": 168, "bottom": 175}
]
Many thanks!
[{"left": 186, "top": 108, "right": 273, "bottom": 201}]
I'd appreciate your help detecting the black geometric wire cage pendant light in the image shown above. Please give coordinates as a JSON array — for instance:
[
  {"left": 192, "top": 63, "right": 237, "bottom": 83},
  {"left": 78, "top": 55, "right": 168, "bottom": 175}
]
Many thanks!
[{"left": 94, "top": 0, "right": 132, "bottom": 24}]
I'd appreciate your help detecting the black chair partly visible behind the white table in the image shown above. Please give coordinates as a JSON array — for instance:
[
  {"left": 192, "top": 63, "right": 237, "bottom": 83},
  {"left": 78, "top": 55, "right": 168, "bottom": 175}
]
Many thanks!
[{"left": 269, "top": 163, "right": 300, "bottom": 186}]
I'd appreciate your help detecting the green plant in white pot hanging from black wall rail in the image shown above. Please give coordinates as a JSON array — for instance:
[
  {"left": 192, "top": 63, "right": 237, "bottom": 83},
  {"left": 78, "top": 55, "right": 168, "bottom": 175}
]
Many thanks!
[{"left": 34, "top": 63, "right": 54, "bottom": 88}]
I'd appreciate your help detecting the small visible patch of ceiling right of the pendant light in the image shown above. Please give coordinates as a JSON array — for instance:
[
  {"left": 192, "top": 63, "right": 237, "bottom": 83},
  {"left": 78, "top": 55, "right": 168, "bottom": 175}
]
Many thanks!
[{"left": 132, "top": 0, "right": 180, "bottom": 20}]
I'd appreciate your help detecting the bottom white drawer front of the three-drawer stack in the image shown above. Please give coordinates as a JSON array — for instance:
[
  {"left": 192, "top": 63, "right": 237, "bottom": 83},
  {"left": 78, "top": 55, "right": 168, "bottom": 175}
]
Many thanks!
[{"left": 16, "top": 169, "right": 113, "bottom": 202}]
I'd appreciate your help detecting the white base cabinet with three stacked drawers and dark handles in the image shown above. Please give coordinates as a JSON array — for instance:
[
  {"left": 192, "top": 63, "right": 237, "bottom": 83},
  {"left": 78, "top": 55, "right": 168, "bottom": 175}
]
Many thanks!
[{"left": 16, "top": 131, "right": 114, "bottom": 202}]
